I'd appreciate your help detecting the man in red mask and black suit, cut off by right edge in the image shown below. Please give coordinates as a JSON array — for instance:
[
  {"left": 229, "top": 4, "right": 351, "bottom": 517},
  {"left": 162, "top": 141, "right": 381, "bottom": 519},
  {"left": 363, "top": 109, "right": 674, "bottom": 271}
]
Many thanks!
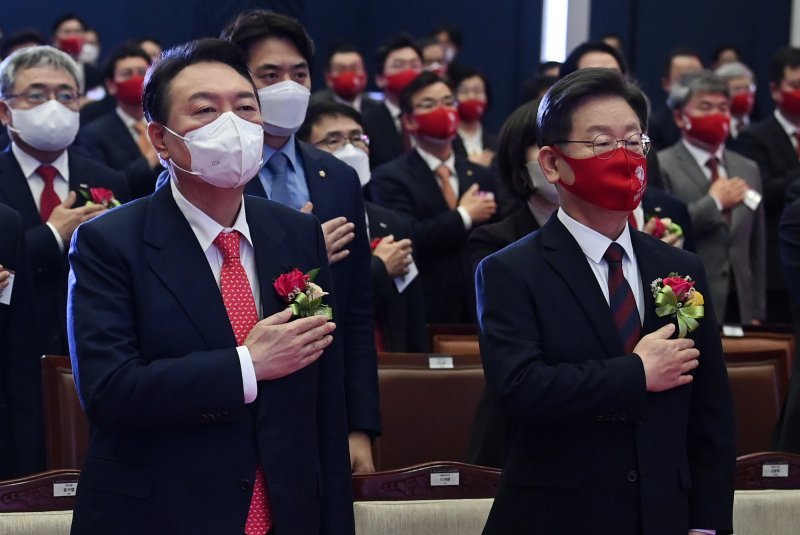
[{"left": 735, "top": 46, "right": 800, "bottom": 323}]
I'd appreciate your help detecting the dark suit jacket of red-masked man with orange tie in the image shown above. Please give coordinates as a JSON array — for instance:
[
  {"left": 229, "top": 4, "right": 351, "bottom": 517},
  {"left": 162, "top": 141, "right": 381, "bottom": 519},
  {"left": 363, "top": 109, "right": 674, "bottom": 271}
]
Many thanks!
[{"left": 370, "top": 150, "right": 494, "bottom": 323}]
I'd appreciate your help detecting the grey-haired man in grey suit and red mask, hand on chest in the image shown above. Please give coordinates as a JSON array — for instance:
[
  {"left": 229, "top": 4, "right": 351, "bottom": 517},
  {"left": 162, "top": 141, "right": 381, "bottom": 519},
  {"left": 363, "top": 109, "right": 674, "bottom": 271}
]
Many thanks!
[{"left": 658, "top": 71, "right": 766, "bottom": 324}]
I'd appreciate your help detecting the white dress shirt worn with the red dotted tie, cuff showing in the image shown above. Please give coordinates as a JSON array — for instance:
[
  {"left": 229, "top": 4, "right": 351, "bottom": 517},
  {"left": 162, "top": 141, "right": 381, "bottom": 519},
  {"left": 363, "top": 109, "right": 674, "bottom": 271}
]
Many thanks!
[{"left": 169, "top": 178, "right": 262, "bottom": 403}]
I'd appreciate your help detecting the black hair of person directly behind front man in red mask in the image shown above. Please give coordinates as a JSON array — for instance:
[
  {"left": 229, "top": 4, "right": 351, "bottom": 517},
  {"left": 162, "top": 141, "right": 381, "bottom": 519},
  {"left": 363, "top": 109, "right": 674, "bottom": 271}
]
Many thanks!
[{"left": 497, "top": 99, "right": 539, "bottom": 200}]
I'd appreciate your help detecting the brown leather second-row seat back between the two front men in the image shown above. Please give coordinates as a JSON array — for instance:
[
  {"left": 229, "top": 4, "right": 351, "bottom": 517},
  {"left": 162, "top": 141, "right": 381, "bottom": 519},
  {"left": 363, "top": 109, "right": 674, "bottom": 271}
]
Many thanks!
[{"left": 374, "top": 353, "right": 484, "bottom": 470}]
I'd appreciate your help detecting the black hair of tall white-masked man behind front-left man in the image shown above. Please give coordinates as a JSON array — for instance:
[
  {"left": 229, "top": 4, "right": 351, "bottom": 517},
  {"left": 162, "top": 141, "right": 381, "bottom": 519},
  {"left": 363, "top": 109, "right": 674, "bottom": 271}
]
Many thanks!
[{"left": 220, "top": 9, "right": 314, "bottom": 73}]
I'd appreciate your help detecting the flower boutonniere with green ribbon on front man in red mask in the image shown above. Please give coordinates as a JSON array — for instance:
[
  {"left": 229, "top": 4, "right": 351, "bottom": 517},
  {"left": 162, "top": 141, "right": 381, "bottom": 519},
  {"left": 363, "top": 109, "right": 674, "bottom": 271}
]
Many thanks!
[{"left": 650, "top": 272, "right": 705, "bottom": 338}]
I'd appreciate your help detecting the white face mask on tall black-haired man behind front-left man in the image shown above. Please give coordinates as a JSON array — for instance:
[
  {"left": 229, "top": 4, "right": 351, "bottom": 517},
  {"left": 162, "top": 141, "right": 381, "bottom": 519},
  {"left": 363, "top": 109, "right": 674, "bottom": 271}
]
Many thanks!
[{"left": 258, "top": 80, "right": 311, "bottom": 136}]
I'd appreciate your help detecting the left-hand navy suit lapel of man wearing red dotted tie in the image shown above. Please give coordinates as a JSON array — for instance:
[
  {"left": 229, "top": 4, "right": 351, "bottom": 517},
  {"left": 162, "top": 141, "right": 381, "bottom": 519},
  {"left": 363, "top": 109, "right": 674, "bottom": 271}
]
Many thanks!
[{"left": 144, "top": 186, "right": 236, "bottom": 348}]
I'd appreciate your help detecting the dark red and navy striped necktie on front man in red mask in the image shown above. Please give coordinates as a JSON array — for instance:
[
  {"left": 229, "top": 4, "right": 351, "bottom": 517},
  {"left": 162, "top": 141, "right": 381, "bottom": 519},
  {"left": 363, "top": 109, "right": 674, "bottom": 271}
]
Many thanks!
[{"left": 603, "top": 242, "right": 642, "bottom": 353}]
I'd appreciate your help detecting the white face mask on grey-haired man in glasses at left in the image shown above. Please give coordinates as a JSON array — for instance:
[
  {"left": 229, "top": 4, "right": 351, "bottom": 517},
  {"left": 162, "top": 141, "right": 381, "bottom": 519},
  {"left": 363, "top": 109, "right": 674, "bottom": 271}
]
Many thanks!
[{"left": 8, "top": 99, "right": 80, "bottom": 150}]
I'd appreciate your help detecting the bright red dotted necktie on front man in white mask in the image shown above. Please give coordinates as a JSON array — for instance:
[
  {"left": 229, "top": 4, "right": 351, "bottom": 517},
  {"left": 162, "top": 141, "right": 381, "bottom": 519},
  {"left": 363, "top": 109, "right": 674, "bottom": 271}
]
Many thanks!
[{"left": 214, "top": 231, "right": 272, "bottom": 535}]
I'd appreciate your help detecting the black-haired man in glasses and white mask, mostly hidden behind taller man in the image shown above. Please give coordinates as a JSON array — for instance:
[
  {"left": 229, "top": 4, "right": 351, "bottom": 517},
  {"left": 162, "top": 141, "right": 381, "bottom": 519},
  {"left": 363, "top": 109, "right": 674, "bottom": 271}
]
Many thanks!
[{"left": 297, "top": 102, "right": 428, "bottom": 352}]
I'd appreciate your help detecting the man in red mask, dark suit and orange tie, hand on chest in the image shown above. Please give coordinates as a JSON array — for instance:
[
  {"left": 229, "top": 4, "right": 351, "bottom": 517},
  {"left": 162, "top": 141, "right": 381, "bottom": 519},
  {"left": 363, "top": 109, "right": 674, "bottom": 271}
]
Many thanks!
[{"left": 370, "top": 72, "right": 497, "bottom": 323}]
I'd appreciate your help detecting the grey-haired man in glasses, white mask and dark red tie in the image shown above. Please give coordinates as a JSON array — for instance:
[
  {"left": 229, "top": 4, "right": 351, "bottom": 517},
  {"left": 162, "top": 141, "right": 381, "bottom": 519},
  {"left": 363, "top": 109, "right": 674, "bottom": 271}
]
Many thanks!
[{"left": 0, "top": 46, "right": 128, "bottom": 355}]
